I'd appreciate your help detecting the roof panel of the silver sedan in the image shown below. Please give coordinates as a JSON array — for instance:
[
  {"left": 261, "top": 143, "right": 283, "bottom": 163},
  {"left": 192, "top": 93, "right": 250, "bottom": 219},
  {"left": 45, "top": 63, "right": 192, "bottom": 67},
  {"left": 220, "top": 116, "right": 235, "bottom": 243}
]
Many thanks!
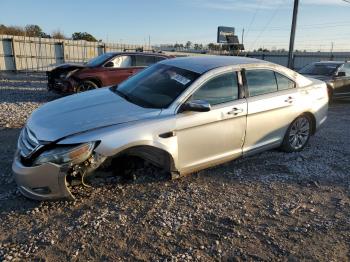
[{"left": 160, "top": 55, "right": 266, "bottom": 74}]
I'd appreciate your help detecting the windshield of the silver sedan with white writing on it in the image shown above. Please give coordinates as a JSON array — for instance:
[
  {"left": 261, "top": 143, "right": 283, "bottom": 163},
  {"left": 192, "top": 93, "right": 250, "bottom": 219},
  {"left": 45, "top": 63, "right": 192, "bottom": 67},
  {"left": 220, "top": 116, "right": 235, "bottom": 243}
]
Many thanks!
[{"left": 112, "top": 64, "right": 200, "bottom": 108}]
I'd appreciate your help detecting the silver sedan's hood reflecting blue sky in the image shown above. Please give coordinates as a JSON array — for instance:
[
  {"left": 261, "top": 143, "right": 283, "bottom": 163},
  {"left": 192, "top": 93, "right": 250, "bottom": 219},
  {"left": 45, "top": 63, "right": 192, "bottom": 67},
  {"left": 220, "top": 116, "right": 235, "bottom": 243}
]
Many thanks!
[{"left": 27, "top": 88, "right": 161, "bottom": 141}]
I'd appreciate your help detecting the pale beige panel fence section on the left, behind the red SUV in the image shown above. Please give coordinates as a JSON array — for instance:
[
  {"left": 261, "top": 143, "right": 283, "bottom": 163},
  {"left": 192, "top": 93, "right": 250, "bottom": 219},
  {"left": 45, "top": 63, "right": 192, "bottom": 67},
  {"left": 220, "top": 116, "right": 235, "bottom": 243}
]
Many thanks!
[{"left": 0, "top": 35, "right": 149, "bottom": 71}]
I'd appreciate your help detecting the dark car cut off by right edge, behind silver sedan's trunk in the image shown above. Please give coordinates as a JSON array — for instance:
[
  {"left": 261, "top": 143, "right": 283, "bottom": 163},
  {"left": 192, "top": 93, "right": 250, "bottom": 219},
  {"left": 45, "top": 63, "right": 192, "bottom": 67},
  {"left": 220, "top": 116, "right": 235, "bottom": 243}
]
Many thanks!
[{"left": 299, "top": 61, "right": 350, "bottom": 100}]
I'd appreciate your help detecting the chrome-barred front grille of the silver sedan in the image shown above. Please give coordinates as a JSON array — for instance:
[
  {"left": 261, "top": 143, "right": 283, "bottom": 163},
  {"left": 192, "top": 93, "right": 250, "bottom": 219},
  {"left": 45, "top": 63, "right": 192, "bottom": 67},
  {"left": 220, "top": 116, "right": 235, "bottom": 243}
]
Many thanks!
[{"left": 18, "top": 127, "right": 41, "bottom": 158}]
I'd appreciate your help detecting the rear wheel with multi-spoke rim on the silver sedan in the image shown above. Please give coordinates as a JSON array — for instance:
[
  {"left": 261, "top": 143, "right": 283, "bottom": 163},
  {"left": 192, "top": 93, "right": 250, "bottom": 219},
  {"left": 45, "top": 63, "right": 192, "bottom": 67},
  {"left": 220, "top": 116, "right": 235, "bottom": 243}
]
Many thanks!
[{"left": 281, "top": 115, "right": 312, "bottom": 153}]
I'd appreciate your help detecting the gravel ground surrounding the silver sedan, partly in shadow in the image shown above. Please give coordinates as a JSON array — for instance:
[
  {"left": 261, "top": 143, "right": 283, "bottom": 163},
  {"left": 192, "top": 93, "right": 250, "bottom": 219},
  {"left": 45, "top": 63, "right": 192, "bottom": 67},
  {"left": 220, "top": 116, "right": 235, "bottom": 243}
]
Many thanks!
[{"left": 0, "top": 72, "right": 350, "bottom": 261}]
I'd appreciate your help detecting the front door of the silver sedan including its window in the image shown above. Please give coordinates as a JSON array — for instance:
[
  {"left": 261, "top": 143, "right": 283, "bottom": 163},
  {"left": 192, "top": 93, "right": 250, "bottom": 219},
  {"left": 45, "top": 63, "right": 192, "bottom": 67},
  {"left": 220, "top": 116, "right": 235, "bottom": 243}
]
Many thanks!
[{"left": 176, "top": 71, "right": 247, "bottom": 173}]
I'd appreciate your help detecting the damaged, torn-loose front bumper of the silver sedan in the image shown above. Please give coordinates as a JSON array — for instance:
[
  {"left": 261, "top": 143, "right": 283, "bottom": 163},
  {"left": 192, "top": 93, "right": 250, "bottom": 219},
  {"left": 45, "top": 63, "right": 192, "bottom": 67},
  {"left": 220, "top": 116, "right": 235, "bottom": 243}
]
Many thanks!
[{"left": 12, "top": 151, "right": 106, "bottom": 200}]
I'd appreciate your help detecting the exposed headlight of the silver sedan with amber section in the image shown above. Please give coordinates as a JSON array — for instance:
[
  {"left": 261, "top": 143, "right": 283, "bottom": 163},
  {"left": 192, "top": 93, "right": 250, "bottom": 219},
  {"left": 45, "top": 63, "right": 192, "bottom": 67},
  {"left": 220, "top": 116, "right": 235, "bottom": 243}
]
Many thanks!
[{"left": 34, "top": 142, "right": 95, "bottom": 165}]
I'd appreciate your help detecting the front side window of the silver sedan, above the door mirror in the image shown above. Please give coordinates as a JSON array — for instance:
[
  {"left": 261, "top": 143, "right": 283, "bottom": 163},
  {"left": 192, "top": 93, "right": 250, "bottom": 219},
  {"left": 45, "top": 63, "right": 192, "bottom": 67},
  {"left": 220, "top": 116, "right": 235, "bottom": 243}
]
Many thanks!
[{"left": 191, "top": 72, "right": 238, "bottom": 105}]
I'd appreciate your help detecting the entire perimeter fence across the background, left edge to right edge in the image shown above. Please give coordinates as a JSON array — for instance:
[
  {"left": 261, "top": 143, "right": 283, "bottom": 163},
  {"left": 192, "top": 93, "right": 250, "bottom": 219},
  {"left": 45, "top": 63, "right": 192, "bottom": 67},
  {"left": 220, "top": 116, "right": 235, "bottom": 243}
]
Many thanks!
[{"left": 0, "top": 35, "right": 350, "bottom": 71}]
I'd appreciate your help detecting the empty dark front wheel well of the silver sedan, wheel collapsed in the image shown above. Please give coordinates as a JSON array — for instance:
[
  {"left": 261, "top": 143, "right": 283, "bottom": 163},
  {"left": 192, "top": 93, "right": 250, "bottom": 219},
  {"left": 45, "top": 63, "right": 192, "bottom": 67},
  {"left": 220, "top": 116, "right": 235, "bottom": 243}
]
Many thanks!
[{"left": 112, "top": 146, "right": 175, "bottom": 172}]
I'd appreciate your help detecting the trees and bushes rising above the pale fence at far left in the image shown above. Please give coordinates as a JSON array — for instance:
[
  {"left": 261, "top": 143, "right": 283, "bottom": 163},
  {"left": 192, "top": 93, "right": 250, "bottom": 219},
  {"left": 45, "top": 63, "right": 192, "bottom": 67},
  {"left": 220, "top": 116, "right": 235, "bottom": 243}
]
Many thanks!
[{"left": 0, "top": 24, "right": 101, "bottom": 42}]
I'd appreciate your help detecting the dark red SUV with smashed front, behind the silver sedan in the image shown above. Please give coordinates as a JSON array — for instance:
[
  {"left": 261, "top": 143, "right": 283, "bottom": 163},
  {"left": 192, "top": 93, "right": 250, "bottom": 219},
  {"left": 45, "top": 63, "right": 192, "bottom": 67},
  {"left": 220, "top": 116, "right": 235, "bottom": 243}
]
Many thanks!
[{"left": 47, "top": 52, "right": 171, "bottom": 94}]
